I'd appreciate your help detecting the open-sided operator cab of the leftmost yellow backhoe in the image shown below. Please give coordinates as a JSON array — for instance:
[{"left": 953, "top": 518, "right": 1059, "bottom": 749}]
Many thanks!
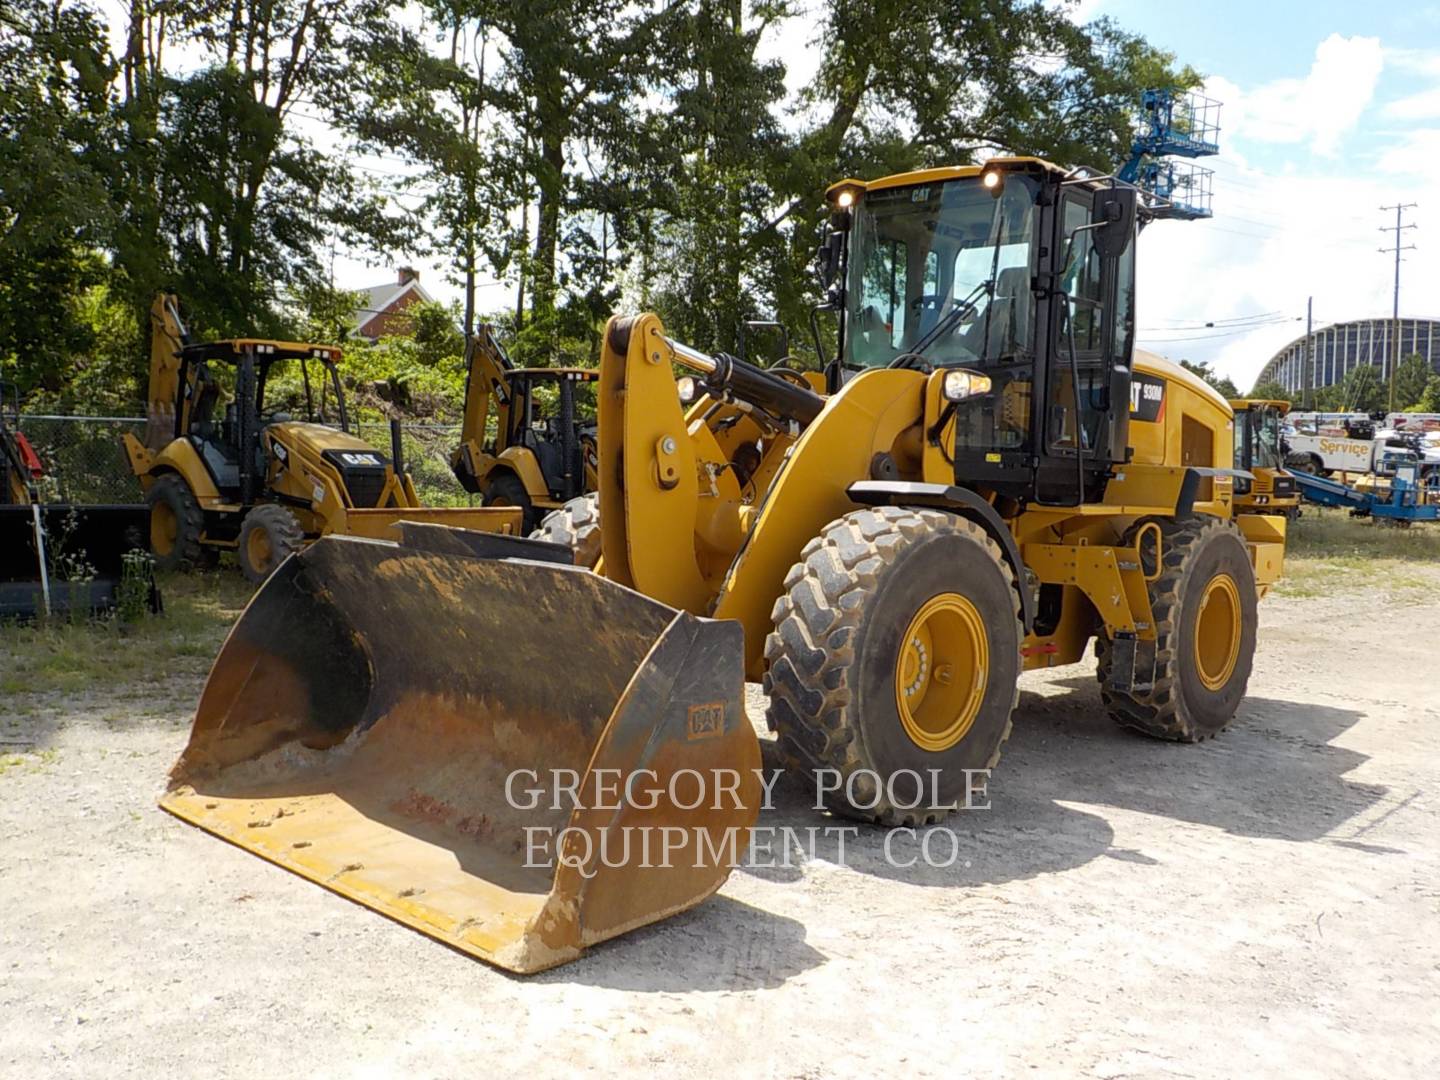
[{"left": 174, "top": 338, "right": 350, "bottom": 504}]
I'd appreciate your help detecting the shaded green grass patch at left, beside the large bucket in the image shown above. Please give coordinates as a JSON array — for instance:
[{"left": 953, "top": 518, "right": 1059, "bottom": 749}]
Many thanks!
[{"left": 0, "top": 570, "right": 251, "bottom": 694}]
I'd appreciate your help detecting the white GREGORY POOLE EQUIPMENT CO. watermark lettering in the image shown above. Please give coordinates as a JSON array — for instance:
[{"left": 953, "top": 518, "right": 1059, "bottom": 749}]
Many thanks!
[{"left": 505, "top": 769, "right": 991, "bottom": 877}]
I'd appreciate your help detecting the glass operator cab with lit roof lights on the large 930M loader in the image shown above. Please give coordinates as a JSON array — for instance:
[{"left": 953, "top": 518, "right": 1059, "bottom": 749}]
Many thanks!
[{"left": 821, "top": 158, "right": 1138, "bottom": 505}]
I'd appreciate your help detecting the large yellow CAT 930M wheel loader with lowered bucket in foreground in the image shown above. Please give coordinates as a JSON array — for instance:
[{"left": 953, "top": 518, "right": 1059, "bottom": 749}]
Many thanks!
[{"left": 163, "top": 158, "right": 1284, "bottom": 971}]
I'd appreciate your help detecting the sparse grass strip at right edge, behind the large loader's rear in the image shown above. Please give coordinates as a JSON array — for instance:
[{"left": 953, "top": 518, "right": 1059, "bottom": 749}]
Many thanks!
[{"left": 1276, "top": 507, "right": 1440, "bottom": 603}]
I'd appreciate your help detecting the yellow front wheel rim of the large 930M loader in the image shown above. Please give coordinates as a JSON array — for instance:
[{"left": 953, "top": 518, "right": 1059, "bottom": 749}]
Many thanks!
[{"left": 896, "top": 592, "right": 989, "bottom": 753}]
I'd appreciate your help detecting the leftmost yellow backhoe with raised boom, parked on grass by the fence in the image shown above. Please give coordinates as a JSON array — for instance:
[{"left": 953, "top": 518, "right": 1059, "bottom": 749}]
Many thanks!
[{"left": 124, "top": 295, "right": 520, "bottom": 582}]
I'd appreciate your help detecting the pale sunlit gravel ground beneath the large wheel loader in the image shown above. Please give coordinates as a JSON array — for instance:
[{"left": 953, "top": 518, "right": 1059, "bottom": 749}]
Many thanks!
[{"left": 0, "top": 569, "right": 1440, "bottom": 1077}]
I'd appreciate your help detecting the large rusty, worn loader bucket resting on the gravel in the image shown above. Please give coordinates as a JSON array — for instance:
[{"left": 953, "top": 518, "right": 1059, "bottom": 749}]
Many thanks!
[{"left": 161, "top": 538, "right": 760, "bottom": 972}]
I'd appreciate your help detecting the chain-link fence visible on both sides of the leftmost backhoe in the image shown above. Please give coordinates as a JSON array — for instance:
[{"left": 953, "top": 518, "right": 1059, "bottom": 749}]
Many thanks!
[{"left": 16, "top": 415, "right": 480, "bottom": 507}]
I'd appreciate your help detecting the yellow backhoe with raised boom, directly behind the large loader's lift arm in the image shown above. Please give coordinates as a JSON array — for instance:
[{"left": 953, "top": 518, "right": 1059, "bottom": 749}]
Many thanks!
[{"left": 451, "top": 325, "right": 598, "bottom": 533}]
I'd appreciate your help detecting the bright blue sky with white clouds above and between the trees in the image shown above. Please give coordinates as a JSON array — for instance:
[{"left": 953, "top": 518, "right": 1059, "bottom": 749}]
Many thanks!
[{"left": 105, "top": 0, "right": 1440, "bottom": 389}]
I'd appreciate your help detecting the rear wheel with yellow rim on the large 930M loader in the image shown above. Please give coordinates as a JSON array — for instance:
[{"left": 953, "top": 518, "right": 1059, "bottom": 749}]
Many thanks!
[{"left": 1096, "top": 514, "right": 1256, "bottom": 743}]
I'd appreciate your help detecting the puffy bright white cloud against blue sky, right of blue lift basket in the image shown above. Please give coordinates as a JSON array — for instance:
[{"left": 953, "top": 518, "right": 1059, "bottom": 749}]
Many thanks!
[{"left": 1205, "top": 33, "right": 1385, "bottom": 157}]
